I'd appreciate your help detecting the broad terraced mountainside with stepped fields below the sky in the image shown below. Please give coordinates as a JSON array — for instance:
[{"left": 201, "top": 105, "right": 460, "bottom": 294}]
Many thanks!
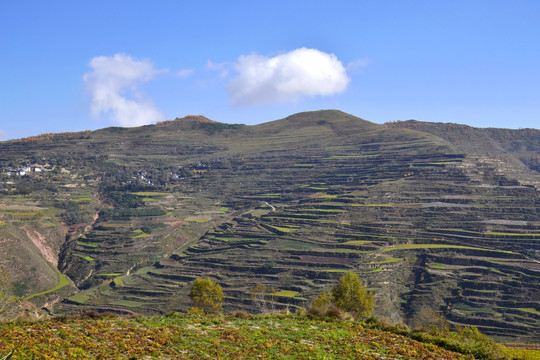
[{"left": 0, "top": 110, "right": 540, "bottom": 342}]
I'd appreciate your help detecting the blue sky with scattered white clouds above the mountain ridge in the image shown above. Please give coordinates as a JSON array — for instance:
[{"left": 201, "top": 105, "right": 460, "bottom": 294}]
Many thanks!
[{"left": 0, "top": 0, "right": 540, "bottom": 139}]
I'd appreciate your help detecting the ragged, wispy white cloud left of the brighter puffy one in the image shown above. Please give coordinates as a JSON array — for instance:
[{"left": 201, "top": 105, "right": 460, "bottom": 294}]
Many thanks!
[{"left": 83, "top": 54, "right": 166, "bottom": 126}]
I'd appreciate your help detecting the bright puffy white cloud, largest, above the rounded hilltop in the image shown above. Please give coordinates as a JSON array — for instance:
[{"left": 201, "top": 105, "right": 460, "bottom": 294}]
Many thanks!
[{"left": 227, "top": 48, "right": 350, "bottom": 106}]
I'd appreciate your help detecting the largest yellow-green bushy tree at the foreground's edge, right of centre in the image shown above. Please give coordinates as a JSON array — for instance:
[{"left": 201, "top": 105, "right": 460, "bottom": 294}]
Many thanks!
[{"left": 331, "top": 272, "right": 375, "bottom": 316}]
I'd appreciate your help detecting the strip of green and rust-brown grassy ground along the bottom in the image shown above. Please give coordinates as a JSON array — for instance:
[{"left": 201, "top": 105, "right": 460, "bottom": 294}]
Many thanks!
[{"left": 0, "top": 314, "right": 533, "bottom": 359}]
